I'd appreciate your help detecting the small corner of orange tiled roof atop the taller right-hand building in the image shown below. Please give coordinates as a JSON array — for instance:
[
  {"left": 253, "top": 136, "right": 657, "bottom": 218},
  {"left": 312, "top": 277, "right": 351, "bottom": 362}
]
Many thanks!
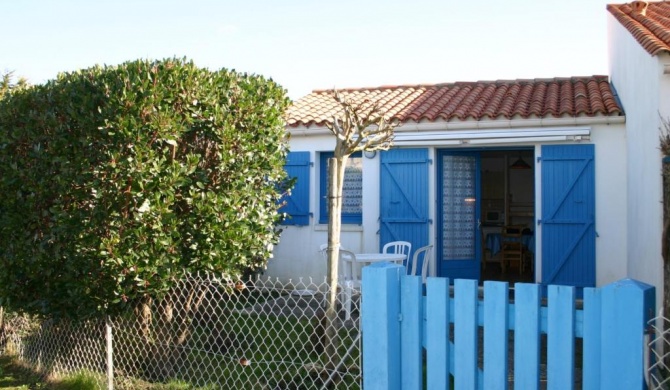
[{"left": 607, "top": 1, "right": 670, "bottom": 55}]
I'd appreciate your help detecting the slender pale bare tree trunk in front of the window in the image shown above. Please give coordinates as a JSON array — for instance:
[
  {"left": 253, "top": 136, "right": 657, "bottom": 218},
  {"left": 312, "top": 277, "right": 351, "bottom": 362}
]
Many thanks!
[{"left": 324, "top": 157, "right": 346, "bottom": 368}]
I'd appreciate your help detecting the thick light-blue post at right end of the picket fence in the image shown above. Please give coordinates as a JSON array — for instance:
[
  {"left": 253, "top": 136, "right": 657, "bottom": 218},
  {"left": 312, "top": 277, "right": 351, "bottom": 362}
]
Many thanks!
[{"left": 600, "top": 279, "right": 655, "bottom": 389}]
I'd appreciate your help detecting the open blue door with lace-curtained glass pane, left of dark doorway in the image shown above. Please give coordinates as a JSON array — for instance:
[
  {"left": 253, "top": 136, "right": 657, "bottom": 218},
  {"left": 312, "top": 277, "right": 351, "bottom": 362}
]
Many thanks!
[{"left": 435, "top": 151, "right": 481, "bottom": 280}]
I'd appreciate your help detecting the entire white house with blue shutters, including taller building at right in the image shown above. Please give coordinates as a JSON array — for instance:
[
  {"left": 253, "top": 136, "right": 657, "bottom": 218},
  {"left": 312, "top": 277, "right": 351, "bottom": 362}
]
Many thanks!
[{"left": 266, "top": 2, "right": 670, "bottom": 308}]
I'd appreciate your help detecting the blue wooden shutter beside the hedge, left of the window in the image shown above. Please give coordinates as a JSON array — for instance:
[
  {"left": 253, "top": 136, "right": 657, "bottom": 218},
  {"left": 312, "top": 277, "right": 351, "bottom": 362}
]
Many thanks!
[{"left": 279, "top": 152, "right": 310, "bottom": 225}]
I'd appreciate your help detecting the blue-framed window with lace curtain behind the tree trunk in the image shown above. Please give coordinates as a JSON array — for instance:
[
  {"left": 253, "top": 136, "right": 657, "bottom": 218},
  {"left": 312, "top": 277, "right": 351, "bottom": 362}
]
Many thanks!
[{"left": 319, "top": 152, "right": 363, "bottom": 224}]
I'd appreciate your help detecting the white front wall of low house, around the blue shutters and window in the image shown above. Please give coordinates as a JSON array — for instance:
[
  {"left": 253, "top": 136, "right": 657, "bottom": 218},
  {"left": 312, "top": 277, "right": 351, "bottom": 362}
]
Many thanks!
[{"left": 266, "top": 124, "right": 627, "bottom": 285}]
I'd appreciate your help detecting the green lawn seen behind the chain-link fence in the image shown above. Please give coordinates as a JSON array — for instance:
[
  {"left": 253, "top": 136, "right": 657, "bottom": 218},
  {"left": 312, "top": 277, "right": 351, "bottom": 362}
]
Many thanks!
[{"left": 108, "top": 288, "right": 360, "bottom": 390}]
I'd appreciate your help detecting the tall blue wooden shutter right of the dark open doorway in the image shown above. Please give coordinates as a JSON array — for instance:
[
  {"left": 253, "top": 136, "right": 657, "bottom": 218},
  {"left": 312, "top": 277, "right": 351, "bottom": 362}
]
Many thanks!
[{"left": 540, "top": 145, "right": 596, "bottom": 287}]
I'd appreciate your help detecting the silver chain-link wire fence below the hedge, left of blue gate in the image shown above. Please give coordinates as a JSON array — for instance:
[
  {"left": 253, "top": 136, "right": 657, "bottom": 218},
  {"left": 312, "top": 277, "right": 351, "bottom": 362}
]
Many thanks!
[{"left": 0, "top": 275, "right": 361, "bottom": 390}]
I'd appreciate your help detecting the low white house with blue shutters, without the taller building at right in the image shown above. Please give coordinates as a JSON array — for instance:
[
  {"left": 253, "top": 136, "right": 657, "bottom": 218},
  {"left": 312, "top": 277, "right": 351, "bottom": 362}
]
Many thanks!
[{"left": 268, "top": 76, "right": 626, "bottom": 286}]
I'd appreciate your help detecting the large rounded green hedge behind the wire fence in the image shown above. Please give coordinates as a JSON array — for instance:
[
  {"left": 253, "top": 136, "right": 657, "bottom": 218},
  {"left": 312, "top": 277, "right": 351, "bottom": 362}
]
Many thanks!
[{"left": 0, "top": 59, "right": 288, "bottom": 318}]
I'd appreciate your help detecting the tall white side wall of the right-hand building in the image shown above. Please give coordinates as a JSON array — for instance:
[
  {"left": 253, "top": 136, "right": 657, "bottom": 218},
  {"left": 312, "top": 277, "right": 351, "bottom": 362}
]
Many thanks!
[{"left": 608, "top": 14, "right": 670, "bottom": 308}]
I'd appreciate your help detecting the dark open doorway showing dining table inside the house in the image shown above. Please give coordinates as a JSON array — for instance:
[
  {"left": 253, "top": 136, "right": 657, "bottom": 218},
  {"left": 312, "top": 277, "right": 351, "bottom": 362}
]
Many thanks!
[{"left": 480, "top": 149, "right": 535, "bottom": 283}]
